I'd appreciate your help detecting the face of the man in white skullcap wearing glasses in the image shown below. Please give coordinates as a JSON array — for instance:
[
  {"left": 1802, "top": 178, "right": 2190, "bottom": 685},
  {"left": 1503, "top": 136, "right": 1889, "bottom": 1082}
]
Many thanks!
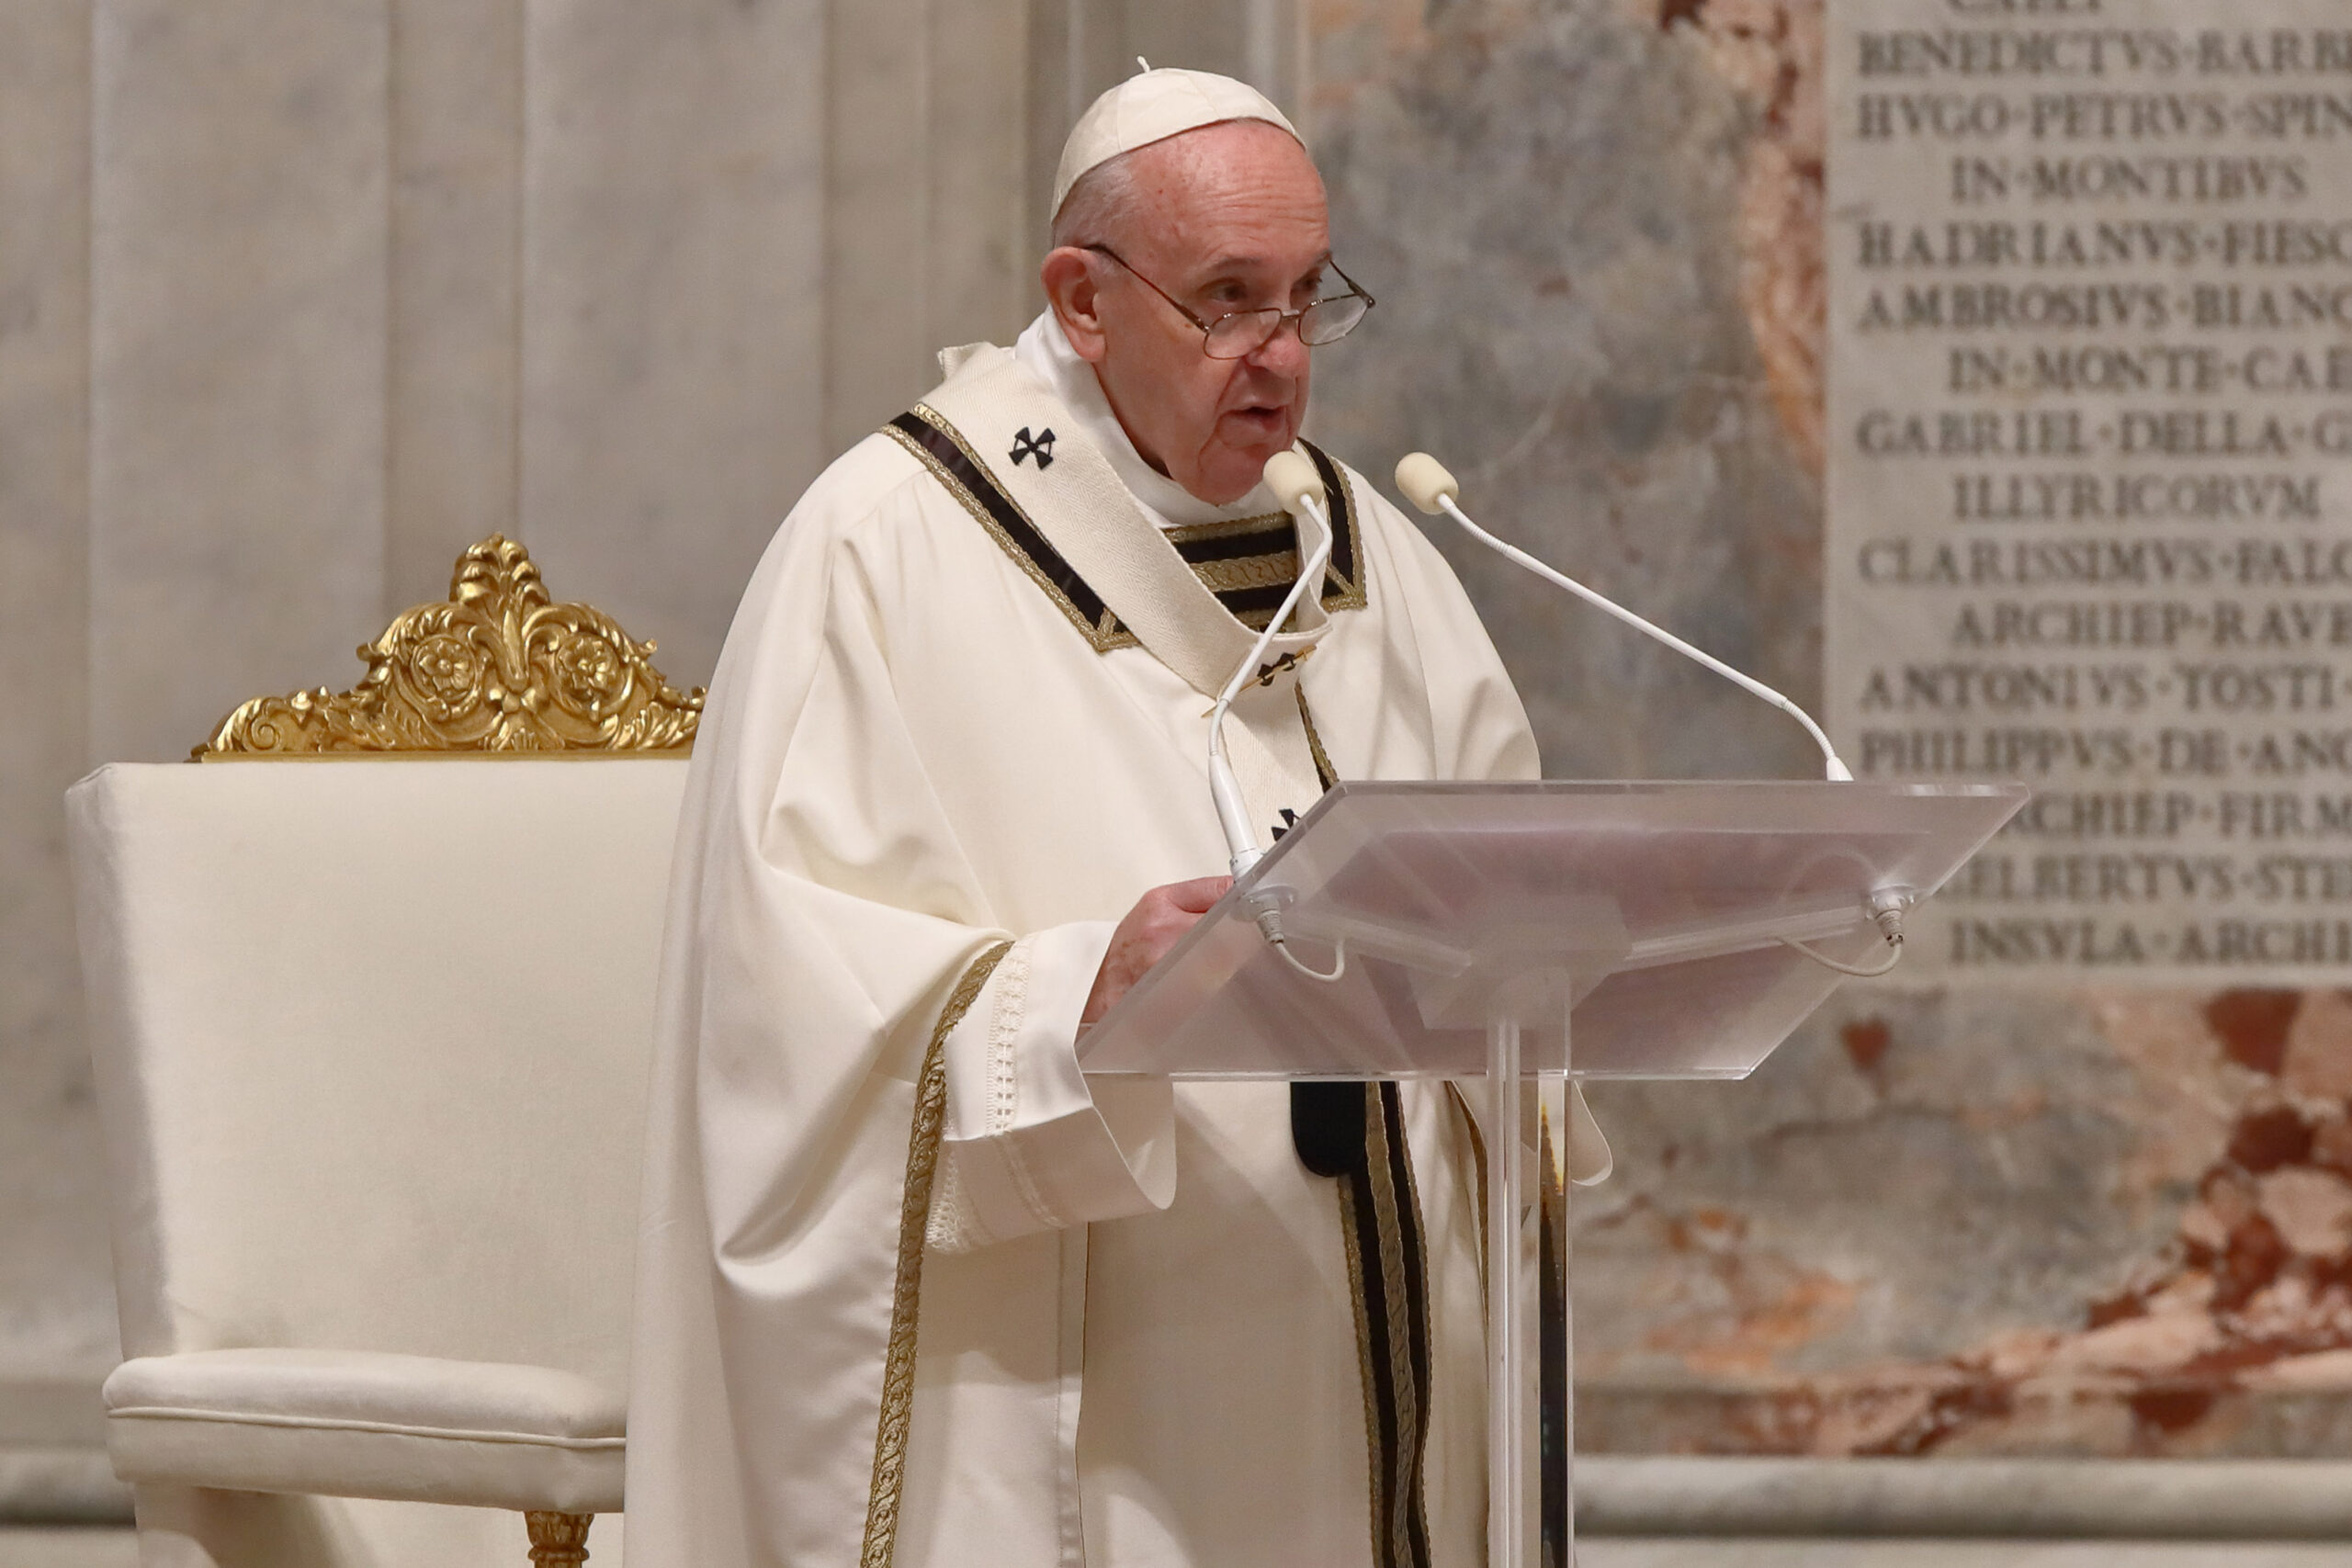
[{"left": 1045, "top": 120, "right": 1331, "bottom": 505}]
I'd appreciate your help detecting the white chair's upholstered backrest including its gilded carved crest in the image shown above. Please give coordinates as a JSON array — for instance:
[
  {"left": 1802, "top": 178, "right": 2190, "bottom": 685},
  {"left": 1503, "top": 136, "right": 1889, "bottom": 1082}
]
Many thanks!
[{"left": 68, "top": 541, "right": 698, "bottom": 1392}]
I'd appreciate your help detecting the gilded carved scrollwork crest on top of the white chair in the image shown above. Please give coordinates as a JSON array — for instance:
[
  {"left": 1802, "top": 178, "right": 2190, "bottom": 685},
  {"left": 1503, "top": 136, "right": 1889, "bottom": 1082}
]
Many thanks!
[{"left": 193, "top": 534, "right": 703, "bottom": 761}]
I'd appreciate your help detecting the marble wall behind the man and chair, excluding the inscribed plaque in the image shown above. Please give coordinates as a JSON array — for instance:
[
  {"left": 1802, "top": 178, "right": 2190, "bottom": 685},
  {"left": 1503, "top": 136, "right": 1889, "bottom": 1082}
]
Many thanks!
[{"left": 18, "top": 0, "right": 2352, "bottom": 1485}]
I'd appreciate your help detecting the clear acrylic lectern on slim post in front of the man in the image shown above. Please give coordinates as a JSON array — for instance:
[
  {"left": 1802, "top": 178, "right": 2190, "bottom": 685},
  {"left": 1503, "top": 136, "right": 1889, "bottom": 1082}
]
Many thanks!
[{"left": 1080, "top": 781, "right": 2025, "bottom": 1568}]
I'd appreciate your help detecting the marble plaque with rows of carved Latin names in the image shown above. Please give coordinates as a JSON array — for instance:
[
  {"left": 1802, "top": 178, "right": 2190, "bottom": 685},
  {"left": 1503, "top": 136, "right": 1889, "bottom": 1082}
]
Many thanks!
[{"left": 1826, "top": 0, "right": 2352, "bottom": 985}]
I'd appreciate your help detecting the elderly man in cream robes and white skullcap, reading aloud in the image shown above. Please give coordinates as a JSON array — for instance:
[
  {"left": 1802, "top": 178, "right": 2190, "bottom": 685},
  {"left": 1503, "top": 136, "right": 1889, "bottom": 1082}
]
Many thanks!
[{"left": 628, "top": 71, "right": 1604, "bottom": 1568}]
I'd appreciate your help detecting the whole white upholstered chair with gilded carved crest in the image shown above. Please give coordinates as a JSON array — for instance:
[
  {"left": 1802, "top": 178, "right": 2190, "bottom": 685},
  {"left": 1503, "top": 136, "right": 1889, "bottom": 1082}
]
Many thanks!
[{"left": 68, "top": 538, "right": 698, "bottom": 1568}]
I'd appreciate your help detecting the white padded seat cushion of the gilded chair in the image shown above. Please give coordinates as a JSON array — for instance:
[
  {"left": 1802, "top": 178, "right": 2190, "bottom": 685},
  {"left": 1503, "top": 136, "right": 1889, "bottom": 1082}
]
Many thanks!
[{"left": 106, "top": 1349, "right": 628, "bottom": 1514}]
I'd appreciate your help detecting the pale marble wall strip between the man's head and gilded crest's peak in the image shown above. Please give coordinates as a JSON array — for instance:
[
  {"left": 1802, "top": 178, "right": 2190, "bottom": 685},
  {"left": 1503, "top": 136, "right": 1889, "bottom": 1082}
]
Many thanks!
[{"left": 517, "top": 0, "right": 828, "bottom": 682}]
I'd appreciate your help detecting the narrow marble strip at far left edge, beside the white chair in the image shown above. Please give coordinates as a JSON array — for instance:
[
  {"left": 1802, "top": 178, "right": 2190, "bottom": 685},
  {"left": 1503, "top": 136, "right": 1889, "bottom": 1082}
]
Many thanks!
[{"left": 0, "top": 0, "right": 115, "bottom": 1392}]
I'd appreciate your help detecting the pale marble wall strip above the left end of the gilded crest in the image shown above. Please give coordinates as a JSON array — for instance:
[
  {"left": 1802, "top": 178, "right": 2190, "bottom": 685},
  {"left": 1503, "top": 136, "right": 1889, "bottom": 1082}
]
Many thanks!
[{"left": 89, "top": 0, "right": 390, "bottom": 761}]
